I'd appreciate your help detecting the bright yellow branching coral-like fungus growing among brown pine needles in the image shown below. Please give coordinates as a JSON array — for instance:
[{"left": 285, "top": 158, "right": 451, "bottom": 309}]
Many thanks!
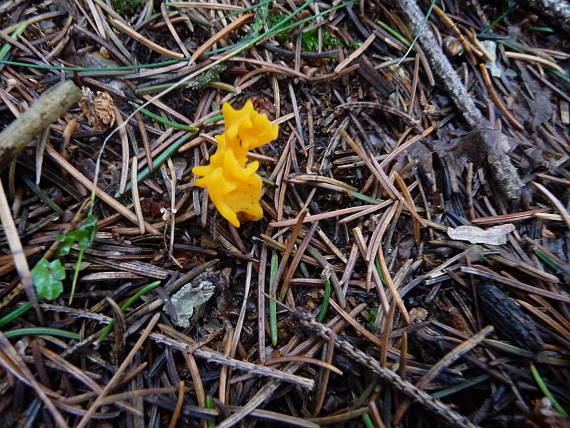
[{"left": 192, "top": 101, "right": 279, "bottom": 227}]
